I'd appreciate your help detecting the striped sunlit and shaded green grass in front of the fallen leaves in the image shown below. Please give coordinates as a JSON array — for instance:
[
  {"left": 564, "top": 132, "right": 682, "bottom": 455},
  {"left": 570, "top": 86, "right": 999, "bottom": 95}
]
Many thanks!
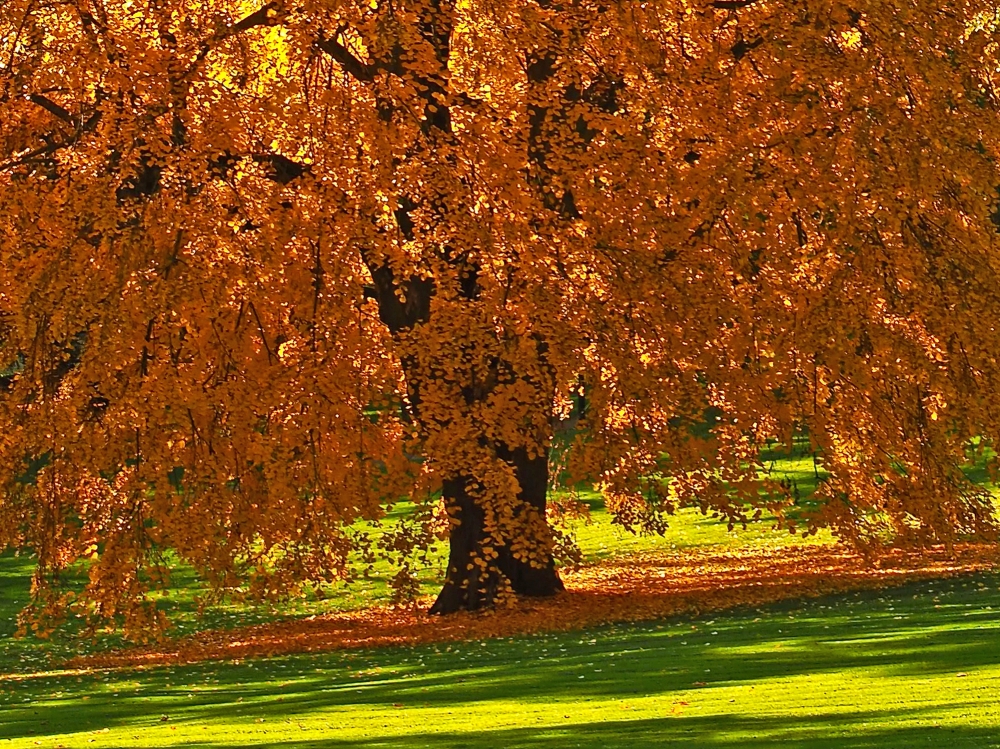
[{"left": 0, "top": 574, "right": 1000, "bottom": 749}]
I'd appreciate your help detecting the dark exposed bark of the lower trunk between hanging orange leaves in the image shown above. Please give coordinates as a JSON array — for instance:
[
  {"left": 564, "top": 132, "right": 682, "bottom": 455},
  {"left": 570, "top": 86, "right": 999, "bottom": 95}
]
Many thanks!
[{"left": 430, "top": 447, "right": 563, "bottom": 614}]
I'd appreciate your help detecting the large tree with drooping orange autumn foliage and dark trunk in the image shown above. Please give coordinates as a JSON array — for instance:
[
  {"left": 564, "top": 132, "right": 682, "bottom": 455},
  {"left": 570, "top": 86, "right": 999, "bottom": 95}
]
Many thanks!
[{"left": 0, "top": 0, "right": 1000, "bottom": 630}]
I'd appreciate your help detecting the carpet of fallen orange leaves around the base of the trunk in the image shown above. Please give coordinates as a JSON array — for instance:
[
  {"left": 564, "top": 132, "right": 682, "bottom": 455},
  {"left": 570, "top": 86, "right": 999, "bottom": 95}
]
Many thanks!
[{"left": 58, "top": 544, "right": 998, "bottom": 669}]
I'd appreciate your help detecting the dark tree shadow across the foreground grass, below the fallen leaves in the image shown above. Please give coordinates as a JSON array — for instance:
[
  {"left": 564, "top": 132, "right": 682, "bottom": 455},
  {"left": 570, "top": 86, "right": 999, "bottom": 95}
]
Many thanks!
[{"left": 0, "top": 574, "right": 1000, "bottom": 749}]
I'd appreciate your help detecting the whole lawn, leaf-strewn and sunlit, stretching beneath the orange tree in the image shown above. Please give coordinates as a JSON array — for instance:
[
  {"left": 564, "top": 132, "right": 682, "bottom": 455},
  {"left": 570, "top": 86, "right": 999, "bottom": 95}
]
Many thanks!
[{"left": 0, "top": 448, "right": 1000, "bottom": 749}]
